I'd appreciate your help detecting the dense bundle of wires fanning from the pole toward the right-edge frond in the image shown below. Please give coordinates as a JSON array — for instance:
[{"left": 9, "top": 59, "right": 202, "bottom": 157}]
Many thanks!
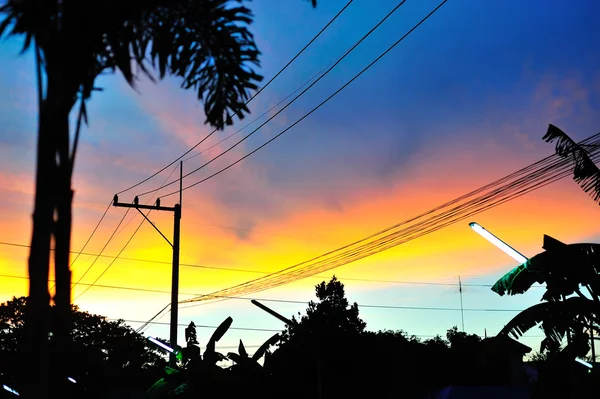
[{"left": 177, "top": 134, "right": 600, "bottom": 303}]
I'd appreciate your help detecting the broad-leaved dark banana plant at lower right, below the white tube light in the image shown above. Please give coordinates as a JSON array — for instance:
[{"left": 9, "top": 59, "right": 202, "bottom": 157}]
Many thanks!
[{"left": 492, "top": 236, "right": 600, "bottom": 358}]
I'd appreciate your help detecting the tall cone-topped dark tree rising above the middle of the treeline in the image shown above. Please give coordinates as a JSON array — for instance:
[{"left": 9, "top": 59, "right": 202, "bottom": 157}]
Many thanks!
[{"left": 265, "top": 276, "right": 366, "bottom": 397}]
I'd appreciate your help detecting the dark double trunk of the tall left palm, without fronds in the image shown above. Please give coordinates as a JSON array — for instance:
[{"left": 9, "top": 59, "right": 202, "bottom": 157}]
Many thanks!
[{"left": 29, "top": 61, "right": 76, "bottom": 398}]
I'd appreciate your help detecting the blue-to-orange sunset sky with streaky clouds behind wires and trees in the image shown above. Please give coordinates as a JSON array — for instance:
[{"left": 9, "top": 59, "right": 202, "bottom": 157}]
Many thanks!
[{"left": 0, "top": 0, "right": 600, "bottom": 352}]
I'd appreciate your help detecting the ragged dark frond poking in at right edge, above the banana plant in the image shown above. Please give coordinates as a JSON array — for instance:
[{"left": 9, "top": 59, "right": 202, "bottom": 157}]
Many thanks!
[{"left": 543, "top": 125, "right": 600, "bottom": 203}]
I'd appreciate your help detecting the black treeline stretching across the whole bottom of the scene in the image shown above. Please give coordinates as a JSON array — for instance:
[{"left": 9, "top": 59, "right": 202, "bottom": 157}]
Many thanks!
[{"left": 0, "top": 277, "right": 597, "bottom": 399}]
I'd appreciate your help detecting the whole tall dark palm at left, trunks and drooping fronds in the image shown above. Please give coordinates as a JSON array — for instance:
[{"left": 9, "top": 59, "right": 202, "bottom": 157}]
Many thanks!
[{"left": 0, "top": 0, "right": 316, "bottom": 398}]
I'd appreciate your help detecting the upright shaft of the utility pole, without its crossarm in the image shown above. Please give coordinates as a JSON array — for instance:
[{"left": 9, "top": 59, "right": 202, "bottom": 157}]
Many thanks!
[{"left": 169, "top": 162, "right": 183, "bottom": 367}]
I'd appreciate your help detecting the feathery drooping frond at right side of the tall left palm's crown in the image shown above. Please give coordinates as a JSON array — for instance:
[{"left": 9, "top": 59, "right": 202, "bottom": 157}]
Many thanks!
[{"left": 145, "top": 0, "right": 262, "bottom": 128}]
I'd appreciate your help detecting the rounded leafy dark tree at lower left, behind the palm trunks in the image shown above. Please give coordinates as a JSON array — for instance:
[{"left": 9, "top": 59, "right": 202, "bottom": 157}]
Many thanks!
[{"left": 0, "top": 297, "right": 166, "bottom": 397}]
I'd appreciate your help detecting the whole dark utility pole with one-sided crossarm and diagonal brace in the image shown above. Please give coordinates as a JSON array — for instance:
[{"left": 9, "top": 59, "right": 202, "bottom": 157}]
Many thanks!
[{"left": 113, "top": 161, "right": 183, "bottom": 367}]
